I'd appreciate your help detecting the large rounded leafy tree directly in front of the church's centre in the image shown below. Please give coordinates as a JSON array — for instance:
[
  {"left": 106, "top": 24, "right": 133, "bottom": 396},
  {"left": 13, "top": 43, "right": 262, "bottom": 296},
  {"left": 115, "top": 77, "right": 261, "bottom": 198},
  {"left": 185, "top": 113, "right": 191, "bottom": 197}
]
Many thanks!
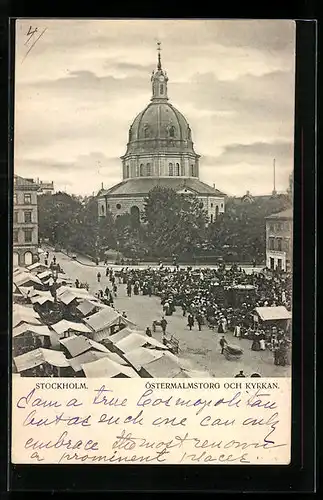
[{"left": 143, "top": 186, "right": 207, "bottom": 257}]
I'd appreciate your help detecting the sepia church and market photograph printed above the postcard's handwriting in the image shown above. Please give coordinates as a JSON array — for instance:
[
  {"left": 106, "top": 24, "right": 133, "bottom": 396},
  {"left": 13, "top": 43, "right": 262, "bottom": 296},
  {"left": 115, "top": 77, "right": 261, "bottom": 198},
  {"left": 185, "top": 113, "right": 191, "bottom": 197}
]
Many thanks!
[{"left": 12, "top": 19, "right": 295, "bottom": 383}]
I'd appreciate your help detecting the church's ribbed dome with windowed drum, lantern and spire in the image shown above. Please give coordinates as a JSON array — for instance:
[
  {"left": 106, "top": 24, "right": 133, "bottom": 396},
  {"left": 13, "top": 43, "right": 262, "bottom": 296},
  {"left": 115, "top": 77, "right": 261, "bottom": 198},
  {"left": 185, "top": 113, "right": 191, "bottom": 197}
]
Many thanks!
[{"left": 121, "top": 44, "right": 199, "bottom": 179}]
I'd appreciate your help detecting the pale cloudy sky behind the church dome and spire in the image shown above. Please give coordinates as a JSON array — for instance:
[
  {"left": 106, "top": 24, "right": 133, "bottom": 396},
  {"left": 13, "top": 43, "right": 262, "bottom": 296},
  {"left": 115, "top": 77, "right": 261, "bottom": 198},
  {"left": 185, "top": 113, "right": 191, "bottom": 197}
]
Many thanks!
[{"left": 14, "top": 19, "right": 295, "bottom": 196}]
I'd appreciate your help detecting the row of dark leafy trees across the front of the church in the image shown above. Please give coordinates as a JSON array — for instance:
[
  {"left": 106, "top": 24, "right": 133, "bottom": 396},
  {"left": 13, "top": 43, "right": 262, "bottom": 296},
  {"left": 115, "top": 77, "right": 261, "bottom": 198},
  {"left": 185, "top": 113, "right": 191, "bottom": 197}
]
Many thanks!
[{"left": 38, "top": 187, "right": 290, "bottom": 262}]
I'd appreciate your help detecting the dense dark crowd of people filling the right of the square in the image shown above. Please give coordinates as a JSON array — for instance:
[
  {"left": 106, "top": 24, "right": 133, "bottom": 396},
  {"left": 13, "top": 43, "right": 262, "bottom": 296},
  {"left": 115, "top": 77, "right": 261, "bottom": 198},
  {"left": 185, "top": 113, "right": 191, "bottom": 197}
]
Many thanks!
[{"left": 102, "top": 265, "right": 292, "bottom": 365}]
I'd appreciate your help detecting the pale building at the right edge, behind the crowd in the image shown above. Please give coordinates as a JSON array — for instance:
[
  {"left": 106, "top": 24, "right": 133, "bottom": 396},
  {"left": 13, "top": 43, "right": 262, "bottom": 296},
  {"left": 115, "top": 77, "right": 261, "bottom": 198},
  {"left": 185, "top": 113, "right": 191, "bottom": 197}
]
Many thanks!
[{"left": 266, "top": 208, "right": 293, "bottom": 272}]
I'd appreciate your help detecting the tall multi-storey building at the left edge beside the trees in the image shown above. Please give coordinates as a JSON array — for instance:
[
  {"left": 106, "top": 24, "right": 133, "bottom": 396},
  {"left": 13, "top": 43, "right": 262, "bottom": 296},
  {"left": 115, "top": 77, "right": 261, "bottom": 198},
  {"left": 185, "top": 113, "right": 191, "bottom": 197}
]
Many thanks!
[{"left": 13, "top": 175, "right": 39, "bottom": 267}]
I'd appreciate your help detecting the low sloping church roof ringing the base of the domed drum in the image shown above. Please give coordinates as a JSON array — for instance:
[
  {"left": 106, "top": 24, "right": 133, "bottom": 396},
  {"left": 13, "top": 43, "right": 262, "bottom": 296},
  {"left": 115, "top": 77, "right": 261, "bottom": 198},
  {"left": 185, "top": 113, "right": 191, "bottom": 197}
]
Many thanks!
[{"left": 101, "top": 177, "right": 226, "bottom": 197}]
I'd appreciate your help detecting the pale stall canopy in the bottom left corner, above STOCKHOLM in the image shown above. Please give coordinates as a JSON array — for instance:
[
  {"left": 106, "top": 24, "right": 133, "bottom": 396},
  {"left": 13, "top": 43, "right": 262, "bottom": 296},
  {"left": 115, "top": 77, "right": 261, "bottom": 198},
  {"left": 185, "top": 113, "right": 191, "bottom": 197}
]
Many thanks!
[{"left": 14, "top": 347, "right": 70, "bottom": 372}]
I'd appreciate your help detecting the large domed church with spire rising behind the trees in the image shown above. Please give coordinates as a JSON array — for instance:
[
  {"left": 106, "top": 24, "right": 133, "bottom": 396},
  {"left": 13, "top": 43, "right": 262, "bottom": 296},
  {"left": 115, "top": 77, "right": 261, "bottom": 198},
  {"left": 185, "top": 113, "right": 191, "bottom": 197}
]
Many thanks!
[{"left": 98, "top": 47, "right": 225, "bottom": 222}]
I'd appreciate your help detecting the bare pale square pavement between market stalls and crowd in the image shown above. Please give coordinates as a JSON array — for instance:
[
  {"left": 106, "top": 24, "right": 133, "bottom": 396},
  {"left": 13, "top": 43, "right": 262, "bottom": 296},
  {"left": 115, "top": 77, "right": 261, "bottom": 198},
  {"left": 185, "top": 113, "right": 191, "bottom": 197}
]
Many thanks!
[{"left": 50, "top": 252, "right": 290, "bottom": 377}]
